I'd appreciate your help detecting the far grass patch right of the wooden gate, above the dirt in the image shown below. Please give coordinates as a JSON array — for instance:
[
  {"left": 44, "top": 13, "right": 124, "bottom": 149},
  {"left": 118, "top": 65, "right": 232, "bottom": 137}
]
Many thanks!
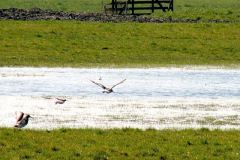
[{"left": 154, "top": 0, "right": 240, "bottom": 22}]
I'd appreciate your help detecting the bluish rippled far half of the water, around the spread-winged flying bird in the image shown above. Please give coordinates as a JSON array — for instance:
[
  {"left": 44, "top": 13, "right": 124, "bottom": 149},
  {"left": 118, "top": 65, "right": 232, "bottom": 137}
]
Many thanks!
[{"left": 0, "top": 68, "right": 240, "bottom": 99}]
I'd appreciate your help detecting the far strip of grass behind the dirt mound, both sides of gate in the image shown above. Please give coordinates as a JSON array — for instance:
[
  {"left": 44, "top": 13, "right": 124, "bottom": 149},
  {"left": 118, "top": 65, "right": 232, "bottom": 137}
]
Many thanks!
[{"left": 0, "top": 0, "right": 240, "bottom": 22}]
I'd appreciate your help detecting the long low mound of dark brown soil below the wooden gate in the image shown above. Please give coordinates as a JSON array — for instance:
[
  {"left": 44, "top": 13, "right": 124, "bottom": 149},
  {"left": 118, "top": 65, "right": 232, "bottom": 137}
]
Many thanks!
[{"left": 0, "top": 8, "right": 228, "bottom": 23}]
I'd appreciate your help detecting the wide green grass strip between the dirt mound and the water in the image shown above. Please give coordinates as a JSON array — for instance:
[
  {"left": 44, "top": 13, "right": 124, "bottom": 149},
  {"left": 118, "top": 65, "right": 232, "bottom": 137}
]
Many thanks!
[{"left": 0, "top": 21, "right": 240, "bottom": 67}]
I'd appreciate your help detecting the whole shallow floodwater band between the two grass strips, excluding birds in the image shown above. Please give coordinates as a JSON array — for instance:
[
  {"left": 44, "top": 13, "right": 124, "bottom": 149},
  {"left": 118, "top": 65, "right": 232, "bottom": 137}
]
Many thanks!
[{"left": 0, "top": 68, "right": 240, "bottom": 129}]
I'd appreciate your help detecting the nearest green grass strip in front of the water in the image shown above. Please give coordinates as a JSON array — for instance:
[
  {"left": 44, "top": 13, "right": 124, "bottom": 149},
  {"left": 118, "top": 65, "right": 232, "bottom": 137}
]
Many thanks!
[{"left": 0, "top": 128, "right": 240, "bottom": 160}]
